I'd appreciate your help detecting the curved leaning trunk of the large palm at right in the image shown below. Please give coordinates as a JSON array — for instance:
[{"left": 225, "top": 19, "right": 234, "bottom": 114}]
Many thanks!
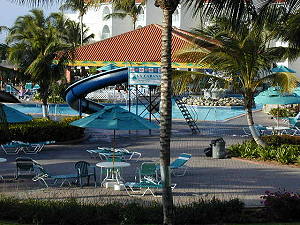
[{"left": 245, "top": 95, "right": 266, "bottom": 147}]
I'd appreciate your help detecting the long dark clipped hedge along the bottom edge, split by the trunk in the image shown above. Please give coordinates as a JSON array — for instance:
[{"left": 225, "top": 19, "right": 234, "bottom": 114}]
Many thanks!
[{"left": 0, "top": 196, "right": 244, "bottom": 225}]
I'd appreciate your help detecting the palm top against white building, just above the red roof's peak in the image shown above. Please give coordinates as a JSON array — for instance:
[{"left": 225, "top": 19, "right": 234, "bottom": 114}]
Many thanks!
[{"left": 104, "top": 0, "right": 145, "bottom": 30}]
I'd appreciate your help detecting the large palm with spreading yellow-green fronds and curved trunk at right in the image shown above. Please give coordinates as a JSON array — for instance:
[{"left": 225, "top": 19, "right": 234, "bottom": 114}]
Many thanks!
[{"left": 178, "top": 17, "right": 299, "bottom": 146}]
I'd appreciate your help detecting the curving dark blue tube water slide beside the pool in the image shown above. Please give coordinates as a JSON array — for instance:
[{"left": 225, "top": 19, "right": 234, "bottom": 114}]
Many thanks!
[{"left": 65, "top": 67, "right": 128, "bottom": 114}]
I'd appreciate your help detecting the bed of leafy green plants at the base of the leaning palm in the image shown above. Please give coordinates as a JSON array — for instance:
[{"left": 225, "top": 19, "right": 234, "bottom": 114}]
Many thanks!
[{"left": 227, "top": 135, "right": 300, "bottom": 165}]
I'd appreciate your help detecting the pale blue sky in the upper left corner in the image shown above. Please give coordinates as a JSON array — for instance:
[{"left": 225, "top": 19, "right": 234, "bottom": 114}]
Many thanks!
[{"left": 0, "top": 0, "right": 59, "bottom": 42}]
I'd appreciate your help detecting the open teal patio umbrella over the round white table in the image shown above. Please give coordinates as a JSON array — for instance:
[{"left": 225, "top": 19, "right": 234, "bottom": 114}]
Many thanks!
[{"left": 71, "top": 105, "right": 159, "bottom": 160}]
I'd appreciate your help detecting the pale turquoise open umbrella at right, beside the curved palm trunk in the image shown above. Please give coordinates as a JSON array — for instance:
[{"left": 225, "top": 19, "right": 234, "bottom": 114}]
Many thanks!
[{"left": 255, "top": 87, "right": 300, "bottom": 126}]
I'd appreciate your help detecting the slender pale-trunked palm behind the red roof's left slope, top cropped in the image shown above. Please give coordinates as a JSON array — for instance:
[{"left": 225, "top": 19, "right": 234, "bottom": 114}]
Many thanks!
[{"left": 59, "top": 0, "right": 99, "bottom": 45}]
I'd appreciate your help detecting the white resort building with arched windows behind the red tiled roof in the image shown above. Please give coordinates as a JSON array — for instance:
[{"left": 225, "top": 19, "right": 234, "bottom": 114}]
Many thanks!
[{"left": 66, "top": 0, "right": 300, "bottom": 76}]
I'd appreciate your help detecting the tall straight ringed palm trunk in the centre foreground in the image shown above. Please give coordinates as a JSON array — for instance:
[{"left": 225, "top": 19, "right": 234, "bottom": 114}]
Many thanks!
[{"left": 160, "top": 9, "right": 173, "bottom": 225}]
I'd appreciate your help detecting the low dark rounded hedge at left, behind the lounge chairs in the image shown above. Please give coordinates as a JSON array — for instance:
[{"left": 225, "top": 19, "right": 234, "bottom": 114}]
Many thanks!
[{"left": 0, "top": 119, "right": 84, "bottom": 143}]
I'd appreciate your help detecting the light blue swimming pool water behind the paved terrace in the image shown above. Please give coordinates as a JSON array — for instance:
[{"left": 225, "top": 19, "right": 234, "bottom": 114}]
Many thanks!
[{"left": 7, "top": 102, "right": 261, "bottom": 121}]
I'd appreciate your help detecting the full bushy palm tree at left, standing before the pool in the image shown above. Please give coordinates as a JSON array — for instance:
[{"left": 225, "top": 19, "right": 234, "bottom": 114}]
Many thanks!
[{"left": 7, "top": 10, "right": 70, "bottom": 117}]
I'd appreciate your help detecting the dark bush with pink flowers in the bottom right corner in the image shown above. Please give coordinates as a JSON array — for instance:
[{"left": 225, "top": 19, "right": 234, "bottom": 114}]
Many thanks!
[{"left": 261, "top": 191, "right": 300, "bottom": 221}]
